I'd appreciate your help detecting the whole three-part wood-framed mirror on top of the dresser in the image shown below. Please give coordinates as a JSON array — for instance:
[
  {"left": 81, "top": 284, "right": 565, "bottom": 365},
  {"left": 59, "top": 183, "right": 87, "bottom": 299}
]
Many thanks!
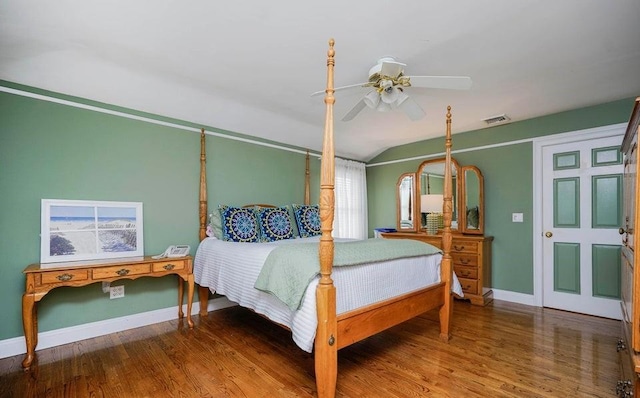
[{"left": 396, "top": 158, "right": 484, "bottom": 235}]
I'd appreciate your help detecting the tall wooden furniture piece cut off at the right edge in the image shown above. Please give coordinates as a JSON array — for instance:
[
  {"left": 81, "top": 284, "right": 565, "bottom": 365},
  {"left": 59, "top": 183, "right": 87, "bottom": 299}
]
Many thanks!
[{"left": 616, "top": 98, "right": 640, "bottom": 397}]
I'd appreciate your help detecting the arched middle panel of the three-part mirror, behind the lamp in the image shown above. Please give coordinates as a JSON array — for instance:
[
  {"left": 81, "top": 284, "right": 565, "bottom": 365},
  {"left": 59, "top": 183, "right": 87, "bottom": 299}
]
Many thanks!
[{"left": 418, "top": 159, "right": 458, "bottom": 234}]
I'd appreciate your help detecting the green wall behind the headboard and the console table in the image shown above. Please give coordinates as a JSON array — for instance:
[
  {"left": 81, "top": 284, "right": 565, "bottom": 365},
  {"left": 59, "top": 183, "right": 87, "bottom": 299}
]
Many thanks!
[{"left": 0, "top": 82, "right": 319, "bottom": 340}]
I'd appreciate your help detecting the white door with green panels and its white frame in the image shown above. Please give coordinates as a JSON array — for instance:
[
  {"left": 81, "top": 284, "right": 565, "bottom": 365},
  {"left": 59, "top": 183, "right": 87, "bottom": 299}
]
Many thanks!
[{"left": 534, "top": 124, "right": 626, "bottom": 319}]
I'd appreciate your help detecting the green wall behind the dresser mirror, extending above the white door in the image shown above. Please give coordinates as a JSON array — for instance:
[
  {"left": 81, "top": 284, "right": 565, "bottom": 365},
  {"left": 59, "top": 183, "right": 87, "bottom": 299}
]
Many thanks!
[{"left": 367, "top": 98, "right": 634, "bottom": 294}]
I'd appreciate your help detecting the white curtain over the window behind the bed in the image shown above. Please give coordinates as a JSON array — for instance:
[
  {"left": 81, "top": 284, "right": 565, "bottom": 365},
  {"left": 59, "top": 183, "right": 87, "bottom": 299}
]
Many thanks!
[{"left": 333, "top": 158, "right": 369, "bottom": 239}]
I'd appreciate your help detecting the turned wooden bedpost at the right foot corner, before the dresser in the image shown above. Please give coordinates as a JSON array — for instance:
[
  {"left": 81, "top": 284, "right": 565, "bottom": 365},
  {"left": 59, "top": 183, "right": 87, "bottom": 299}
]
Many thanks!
[{"left": 440, "top": 106, "right": 453, "bottom": 341}]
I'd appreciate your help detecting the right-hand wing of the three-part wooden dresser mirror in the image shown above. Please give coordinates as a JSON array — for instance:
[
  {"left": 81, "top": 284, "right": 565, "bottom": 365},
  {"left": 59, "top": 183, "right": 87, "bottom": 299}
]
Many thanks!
[{"left": 460, "top": 166, "right": 484, "bottom": 235}]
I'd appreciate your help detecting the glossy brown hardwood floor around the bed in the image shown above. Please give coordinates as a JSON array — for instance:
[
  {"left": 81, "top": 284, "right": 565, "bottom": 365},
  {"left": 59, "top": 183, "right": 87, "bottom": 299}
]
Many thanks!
[{"left": 0, "top": 301, "right": 620, "bottom": 398}]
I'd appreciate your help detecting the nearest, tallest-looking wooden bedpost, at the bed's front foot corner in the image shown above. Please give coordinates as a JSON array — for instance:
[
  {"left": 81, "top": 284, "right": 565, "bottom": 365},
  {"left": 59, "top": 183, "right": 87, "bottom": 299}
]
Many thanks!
[{"left": 315, "top": 39, "right": 338, "bottom": 398}]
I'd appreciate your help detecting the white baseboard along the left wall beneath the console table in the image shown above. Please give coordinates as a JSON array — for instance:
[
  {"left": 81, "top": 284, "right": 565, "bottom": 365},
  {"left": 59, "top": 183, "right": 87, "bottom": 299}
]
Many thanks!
[{"left": 0, "top": 297, "right": 237, "bottom": 358}]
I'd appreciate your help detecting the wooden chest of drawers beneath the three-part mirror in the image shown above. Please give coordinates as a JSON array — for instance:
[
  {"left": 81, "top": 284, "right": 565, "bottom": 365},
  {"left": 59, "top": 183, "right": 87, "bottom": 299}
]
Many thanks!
[{"left": 382, "top": 232, "right": 493, "bottom": 305}]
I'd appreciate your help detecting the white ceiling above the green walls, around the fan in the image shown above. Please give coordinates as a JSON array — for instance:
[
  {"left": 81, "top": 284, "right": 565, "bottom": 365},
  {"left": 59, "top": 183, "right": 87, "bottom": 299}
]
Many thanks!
[{"left": 0, "top": 0, "right": 640, "bottom": 161}]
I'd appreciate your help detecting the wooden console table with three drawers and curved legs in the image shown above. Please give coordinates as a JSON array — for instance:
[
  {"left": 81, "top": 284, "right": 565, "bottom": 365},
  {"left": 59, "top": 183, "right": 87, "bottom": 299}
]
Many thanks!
[{"left": 22, "top": 256, "right": 194, "bottom": 370}]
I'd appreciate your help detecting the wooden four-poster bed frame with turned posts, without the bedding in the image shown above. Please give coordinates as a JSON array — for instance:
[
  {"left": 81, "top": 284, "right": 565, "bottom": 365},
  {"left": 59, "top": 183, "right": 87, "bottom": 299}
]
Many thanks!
[{"left": 194, "top": 40, "right": 457, "bottom": 397}]
